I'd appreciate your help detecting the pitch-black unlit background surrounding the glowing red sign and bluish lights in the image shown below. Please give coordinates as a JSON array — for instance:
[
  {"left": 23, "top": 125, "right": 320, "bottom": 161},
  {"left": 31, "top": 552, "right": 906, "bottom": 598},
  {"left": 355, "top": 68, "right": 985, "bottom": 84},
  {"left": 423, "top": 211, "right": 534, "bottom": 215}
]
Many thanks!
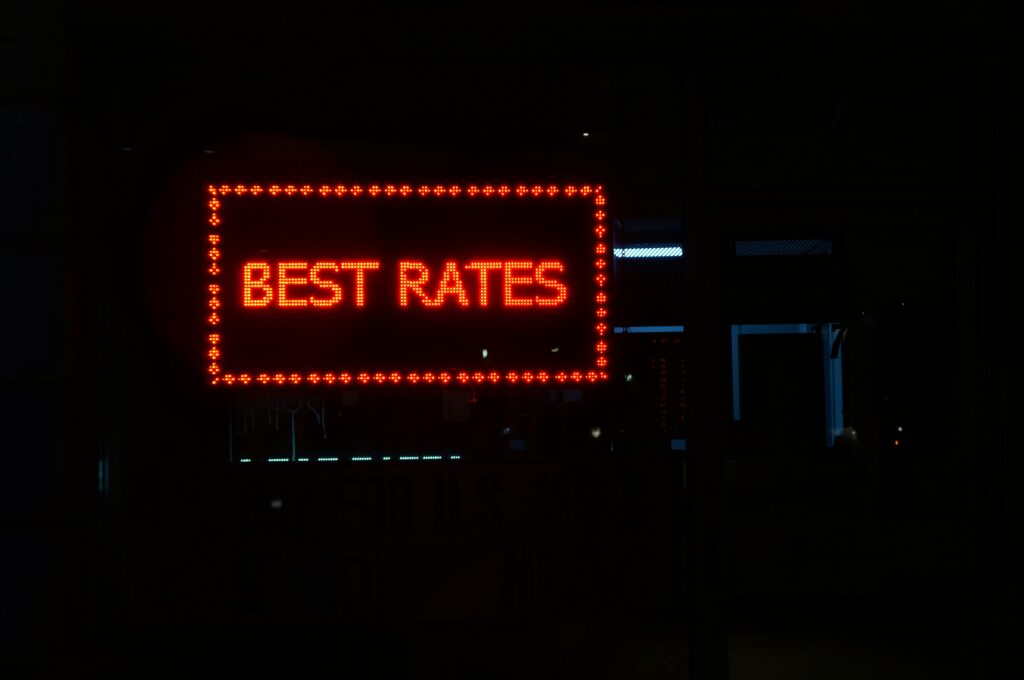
[{"left": 0, "top": 1, "right": 1021, "bottom": 678}]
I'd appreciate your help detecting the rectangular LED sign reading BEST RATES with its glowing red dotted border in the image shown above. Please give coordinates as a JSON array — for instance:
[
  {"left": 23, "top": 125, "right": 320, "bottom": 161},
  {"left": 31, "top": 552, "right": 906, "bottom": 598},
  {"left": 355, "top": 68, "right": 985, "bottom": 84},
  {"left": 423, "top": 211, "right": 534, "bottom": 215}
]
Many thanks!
[{"left": 204, "top": 183, "right": 611, "bottom": 386}]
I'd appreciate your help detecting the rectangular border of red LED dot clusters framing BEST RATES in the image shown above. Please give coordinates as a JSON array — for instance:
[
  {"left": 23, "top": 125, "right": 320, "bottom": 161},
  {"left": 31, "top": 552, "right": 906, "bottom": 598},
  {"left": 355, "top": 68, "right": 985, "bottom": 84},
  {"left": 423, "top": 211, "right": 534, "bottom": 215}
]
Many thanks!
[{"left": 204, "top": 183, "right": 611, "bottom": 387}]
